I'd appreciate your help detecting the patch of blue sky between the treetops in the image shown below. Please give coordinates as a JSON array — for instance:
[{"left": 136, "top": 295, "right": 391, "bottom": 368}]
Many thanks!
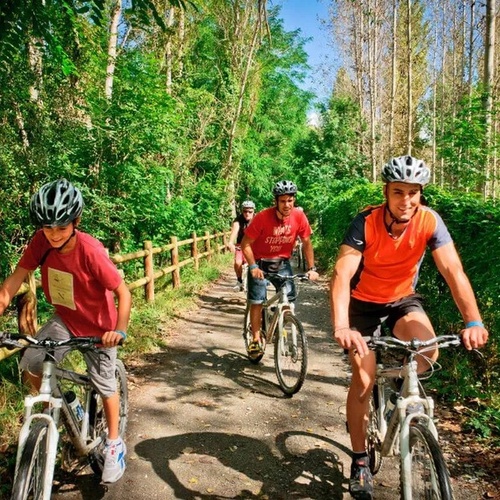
[{"left": 269, "top": 0, "right": 335, "bottom": 100}]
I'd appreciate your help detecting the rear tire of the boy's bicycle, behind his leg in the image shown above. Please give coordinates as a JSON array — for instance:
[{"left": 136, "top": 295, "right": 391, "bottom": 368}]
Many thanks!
[{"left": 89, "top": 359, "right": 128, "bottom": 477}]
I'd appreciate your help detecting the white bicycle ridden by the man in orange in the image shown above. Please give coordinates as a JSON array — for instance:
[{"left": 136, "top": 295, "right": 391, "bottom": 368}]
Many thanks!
[{"left": 365, "top": 335, "right": 461, "bottom": 500}]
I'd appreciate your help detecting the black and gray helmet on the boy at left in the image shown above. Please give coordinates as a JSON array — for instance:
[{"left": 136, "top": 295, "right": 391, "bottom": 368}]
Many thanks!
[{"left": 30, "top": 179, "right": 83, "bottom": 227}]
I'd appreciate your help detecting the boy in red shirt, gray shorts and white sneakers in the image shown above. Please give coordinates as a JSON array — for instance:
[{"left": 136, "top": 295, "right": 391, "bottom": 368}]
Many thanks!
[{"left": 0, "top": 179, "right": 131, "bottom": 483}]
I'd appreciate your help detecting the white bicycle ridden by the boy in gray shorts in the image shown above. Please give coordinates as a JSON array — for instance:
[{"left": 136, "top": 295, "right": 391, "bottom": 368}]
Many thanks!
[{"left": 0, "top": 332, "right": 128, "bottom": 500}]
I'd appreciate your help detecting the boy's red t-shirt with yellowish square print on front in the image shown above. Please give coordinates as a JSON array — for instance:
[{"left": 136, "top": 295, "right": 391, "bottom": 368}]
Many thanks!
[{"left": 19, "top": 230, "right": 122, "bottom": 337}]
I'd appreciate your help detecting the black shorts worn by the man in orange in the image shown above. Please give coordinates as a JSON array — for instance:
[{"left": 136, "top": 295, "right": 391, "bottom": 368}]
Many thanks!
[{"left": 349, "top": 293, "right": 425, "bottom": 337}]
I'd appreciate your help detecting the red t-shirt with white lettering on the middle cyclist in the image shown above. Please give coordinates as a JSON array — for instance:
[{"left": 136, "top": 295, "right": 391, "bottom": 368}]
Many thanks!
[{"left": 245, "top": 207, "right": 312, "bottom": 260}]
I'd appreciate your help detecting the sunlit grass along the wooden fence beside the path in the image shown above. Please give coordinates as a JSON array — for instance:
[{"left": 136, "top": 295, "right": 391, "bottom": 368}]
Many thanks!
[{"left": 0, "top": 254, "right": 232, "bottom": 499}]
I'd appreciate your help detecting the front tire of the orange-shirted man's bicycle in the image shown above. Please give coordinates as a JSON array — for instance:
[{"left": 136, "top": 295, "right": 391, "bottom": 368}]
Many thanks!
[{"left": 401, "top": 423, "right": 453, "bottom": 500}]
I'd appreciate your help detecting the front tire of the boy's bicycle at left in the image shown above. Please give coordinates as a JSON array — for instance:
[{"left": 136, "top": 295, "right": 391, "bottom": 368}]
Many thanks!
[{"left": 11, "top": 420, "right": 54, "bottom": 500}]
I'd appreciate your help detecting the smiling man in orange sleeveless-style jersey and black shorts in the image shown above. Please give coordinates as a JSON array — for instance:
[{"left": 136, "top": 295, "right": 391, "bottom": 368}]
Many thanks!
[{"left": 330, "top": 156, "right": 488, "bottom": 499}]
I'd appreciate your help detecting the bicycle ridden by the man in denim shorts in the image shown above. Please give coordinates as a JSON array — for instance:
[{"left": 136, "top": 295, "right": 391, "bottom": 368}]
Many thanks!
[{"left": 243, "top": 273, "right": 308, "bottom": 396}]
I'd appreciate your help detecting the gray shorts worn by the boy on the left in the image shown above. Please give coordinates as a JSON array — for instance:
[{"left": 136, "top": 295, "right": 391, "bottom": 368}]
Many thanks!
[{"left": 20, "top": 316, "right": 117, "bottom": 398}]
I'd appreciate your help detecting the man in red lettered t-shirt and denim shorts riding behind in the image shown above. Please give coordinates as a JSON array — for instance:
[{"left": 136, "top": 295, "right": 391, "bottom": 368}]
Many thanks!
[{"left": 241, "top": 181, "right": 318, "bottom": 356}]
